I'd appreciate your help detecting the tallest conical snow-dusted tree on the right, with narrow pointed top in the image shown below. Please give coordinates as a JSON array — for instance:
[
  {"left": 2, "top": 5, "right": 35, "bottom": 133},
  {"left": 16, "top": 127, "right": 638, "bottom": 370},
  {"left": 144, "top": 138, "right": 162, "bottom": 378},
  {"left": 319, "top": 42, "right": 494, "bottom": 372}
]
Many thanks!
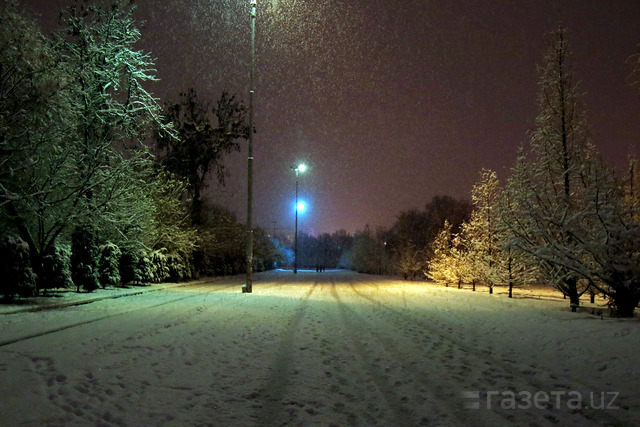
[{"left": 504, "top": 28, "right": 594, "bottom": 310}]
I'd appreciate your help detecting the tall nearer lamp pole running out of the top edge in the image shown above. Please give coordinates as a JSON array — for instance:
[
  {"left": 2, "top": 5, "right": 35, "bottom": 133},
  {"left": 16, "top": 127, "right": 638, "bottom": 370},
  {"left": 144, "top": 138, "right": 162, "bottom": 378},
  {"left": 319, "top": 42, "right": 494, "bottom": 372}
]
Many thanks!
[{"left": 242, "top": 0, "right": 257, "bottom": 293}]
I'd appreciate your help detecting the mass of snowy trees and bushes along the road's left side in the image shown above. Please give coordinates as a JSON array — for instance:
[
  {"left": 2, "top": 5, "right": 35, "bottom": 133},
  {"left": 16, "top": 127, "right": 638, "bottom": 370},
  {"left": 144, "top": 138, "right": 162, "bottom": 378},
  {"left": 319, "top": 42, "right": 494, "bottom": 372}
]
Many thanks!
[{"left": 0, "top": 0, "right": 282, "bottom": 298}]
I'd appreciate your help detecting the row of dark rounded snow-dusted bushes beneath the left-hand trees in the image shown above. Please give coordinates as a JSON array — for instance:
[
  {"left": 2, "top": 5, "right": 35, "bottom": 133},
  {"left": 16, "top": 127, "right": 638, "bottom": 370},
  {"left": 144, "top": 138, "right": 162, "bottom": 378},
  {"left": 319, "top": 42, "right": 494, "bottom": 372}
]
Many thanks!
[{"left": 0, "top": 232, "right": 197, "bottom": 299}]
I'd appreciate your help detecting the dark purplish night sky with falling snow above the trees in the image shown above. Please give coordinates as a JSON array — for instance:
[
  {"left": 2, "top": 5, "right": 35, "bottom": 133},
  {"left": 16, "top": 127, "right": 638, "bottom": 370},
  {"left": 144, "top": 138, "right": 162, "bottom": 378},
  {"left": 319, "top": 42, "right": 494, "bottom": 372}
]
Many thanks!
[{"left": 22, "top": 0, "right": 640, "bottom": 234}]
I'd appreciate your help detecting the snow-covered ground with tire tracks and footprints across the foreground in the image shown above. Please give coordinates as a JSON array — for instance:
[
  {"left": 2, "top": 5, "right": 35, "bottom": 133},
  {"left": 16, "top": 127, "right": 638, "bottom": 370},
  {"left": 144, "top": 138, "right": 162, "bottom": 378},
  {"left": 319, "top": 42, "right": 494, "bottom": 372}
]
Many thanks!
[{"left": 0, "top": 271, "right": 640, "bottom": 426}]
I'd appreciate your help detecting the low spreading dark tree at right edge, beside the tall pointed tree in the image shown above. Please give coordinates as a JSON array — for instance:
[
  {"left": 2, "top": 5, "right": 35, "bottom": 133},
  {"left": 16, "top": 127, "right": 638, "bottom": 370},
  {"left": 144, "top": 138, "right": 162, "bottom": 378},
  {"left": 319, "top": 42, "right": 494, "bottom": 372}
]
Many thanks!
[{"left": 512, "top": 155, "right": 640, "bottom": 317}]
